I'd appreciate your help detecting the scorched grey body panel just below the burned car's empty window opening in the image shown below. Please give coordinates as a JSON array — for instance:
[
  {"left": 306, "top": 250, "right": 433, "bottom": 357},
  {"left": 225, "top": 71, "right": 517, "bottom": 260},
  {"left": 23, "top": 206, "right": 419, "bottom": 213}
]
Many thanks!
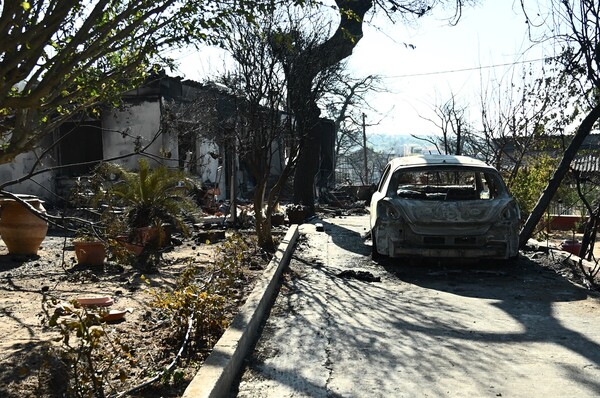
[{"left": 388, "top": 196, "right": 513, "bottom": 232}]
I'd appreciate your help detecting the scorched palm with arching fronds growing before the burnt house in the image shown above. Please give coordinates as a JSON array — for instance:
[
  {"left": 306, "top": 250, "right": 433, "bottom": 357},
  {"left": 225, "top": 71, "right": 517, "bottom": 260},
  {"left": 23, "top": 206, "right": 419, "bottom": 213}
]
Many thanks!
[{"left": 68, "top": 158, "right": 199, "bottom": 270}]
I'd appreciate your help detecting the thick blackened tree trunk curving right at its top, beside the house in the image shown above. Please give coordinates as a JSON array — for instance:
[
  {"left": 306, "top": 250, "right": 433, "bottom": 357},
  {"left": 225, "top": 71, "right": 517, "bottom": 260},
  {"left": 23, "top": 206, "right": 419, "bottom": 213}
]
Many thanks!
[{"left": 274, "top": 0, "right": 474, "bottom": 214}]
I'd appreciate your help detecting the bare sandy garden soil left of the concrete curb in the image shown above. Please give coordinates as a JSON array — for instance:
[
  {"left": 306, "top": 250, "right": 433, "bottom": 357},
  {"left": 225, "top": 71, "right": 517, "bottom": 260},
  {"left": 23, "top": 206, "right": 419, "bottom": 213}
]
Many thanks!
[{"left": 0, "top": 227, "right": 278, "bottom": 397}]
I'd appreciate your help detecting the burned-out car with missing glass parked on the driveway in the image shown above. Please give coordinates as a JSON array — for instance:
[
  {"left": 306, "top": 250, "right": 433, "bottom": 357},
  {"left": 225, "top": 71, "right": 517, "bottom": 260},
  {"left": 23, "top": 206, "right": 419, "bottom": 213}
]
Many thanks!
[{"left": 370, "top": 155, "right": 520, "bottom": 259}]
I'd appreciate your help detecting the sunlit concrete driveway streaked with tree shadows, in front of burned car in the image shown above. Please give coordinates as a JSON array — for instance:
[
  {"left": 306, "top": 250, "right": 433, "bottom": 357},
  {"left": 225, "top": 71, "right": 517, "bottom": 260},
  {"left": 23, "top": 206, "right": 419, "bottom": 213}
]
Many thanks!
[{"left": 232, "top": 216, "right": 600, "bottom": 398}]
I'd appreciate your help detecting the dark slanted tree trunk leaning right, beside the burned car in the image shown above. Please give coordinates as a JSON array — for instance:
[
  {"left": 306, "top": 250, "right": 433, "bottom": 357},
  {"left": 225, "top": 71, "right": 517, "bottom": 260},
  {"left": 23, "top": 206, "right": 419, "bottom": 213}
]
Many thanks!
[{"left": 519, "top": 104, "right": 600, "bottom": 247}]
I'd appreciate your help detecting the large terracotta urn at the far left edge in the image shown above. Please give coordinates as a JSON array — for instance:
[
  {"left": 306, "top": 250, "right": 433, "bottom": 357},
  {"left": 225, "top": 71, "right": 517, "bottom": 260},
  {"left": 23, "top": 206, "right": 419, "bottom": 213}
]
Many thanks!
[{"left": 0, "top": 195, "right": 48, "bottom": 255}]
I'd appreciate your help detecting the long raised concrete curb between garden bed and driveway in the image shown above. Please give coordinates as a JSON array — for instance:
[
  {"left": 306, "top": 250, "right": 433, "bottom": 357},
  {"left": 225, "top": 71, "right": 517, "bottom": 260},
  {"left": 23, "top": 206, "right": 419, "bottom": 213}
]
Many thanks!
[{"left": 182, "top": 224, "right": 298, "bottom": 398}]
